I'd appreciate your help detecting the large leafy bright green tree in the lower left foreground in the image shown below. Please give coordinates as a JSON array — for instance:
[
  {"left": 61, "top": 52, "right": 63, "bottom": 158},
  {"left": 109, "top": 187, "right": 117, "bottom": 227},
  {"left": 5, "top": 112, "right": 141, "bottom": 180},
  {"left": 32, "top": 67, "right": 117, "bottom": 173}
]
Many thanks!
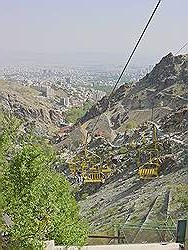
[{"left": 0, "top": 114, "right": 87, "bottom": 250}]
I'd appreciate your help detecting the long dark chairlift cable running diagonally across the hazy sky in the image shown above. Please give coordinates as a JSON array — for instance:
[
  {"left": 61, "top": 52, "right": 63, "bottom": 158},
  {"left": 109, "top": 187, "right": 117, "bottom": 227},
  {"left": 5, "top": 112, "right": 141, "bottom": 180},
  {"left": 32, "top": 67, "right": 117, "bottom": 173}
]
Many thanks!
[{"left": 85, "top": 0, "right": 162, "bottom": 146}]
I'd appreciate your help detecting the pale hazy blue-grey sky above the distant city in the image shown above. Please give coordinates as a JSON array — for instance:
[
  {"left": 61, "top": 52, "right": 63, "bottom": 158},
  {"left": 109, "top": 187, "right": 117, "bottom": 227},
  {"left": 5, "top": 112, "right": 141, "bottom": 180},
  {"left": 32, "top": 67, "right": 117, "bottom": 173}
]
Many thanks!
[{"left": 0, "top": 0, "right": 188, "bottom": 64}]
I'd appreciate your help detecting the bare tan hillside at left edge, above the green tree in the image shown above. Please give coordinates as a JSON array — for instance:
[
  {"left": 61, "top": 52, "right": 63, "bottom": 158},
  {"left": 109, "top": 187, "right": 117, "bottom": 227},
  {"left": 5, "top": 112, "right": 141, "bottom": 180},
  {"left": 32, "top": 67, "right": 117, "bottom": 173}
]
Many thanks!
[{"left": 0, "top": 81, "right": 62, "bottom": 133}]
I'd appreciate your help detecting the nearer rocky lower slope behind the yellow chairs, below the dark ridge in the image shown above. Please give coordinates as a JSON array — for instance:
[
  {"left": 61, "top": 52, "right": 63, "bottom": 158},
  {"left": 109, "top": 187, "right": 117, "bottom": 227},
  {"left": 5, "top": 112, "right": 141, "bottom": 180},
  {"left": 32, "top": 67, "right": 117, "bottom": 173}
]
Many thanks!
[{"left": 78, "top": 107, "right": 188, "bottom": 238}]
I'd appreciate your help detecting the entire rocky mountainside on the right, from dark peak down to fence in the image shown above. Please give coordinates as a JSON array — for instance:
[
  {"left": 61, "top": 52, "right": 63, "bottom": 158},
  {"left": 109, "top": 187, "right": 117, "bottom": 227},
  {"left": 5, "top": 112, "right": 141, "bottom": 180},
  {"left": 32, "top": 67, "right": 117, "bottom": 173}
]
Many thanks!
[{"left": 72, "top": 53, "right": 188, "bottom": 238}]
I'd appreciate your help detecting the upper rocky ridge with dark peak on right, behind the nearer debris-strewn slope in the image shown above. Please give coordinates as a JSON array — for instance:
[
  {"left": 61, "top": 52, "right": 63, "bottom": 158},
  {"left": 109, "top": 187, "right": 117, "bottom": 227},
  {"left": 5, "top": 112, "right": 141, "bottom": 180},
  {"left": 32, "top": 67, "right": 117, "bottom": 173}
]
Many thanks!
[{"left": 79, "top": 53, "right": 188, "bottom": 139}]
